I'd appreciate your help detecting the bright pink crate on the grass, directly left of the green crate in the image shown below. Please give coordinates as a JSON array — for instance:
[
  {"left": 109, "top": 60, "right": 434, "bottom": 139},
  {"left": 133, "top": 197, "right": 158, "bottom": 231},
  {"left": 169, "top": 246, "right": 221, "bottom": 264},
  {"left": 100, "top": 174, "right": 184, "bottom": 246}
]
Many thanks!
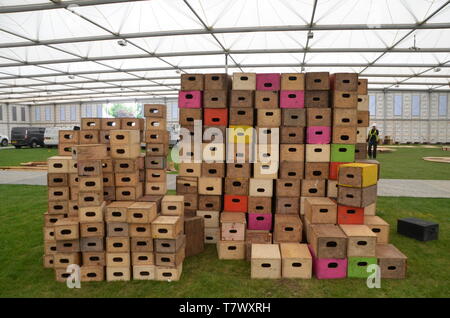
[{"left": 308, "top": 244, "right": 347, "bottom": 279}]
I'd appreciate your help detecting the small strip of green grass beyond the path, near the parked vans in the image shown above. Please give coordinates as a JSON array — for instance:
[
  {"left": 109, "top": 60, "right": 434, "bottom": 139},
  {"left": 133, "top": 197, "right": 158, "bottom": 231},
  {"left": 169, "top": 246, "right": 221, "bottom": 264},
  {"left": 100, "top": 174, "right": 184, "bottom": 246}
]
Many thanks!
[{"left": 0, "top": 148, "right": 58, "bottom": 167}]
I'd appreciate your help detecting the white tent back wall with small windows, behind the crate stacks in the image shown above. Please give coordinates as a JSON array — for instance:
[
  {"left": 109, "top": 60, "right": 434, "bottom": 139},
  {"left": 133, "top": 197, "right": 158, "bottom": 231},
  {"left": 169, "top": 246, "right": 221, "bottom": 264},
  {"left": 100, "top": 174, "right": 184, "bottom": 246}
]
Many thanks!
[{"left": 0, "top": 90, "right": 450, "bottom": 143}]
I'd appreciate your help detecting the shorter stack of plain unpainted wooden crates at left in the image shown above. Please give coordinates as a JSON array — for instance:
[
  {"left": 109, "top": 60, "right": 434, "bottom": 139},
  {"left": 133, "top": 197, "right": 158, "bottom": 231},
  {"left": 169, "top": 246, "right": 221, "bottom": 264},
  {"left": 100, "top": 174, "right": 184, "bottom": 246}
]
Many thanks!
[{"left": 44, "top": 108, "right": 195, "bottom": 282}]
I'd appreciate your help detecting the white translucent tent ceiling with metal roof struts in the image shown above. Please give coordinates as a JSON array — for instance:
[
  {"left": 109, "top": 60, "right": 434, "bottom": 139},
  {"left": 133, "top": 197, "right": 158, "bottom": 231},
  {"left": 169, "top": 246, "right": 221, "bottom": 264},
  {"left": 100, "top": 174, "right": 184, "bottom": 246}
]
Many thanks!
[{"left": 0, "top": 0, "right": 450, "bottom": 104}]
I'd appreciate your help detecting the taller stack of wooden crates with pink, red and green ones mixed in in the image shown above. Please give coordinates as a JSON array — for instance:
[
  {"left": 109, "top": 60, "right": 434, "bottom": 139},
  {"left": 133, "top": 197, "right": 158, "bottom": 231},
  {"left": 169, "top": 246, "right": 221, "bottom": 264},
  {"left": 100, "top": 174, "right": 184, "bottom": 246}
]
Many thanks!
[{"left": 177, "top": 72, "right": 406, "bottom": 278}]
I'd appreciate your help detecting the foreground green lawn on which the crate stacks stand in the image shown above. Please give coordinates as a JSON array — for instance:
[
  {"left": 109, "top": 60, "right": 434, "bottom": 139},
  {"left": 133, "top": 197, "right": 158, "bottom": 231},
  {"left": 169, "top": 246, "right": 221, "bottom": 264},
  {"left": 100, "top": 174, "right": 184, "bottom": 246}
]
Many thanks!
[{"left": 0, "top": 185, "right": 450, "bottom": 297}]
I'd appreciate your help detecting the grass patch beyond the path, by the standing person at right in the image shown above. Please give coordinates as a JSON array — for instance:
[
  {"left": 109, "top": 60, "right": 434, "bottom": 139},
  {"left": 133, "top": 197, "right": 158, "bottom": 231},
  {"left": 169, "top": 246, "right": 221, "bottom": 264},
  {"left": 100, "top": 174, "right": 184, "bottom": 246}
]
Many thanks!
[{"left": 377, "top": 147, "right": 450, "bottom": 180}]
